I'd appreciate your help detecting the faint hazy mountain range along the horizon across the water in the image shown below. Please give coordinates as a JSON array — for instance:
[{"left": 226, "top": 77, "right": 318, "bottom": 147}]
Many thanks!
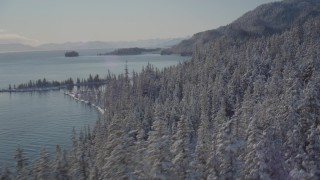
[{"left": 0, "top": 37, "right": 187, "bottom": 52}]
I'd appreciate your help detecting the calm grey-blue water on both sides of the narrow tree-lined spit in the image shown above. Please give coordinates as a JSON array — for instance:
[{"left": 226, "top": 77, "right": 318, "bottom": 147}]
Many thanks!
[{"left": 0, "top": 50, "right": 189, "bottom": 166}]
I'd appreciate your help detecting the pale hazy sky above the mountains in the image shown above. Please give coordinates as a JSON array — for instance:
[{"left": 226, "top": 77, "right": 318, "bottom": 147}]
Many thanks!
[{"left": 0, "top": 0, "right": 275, "bottom": 44}]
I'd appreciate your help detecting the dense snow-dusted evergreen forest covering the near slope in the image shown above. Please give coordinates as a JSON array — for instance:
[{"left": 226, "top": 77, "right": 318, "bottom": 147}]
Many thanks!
[{"left": 1, "top": 0, "right": 320, "bottom": 180}]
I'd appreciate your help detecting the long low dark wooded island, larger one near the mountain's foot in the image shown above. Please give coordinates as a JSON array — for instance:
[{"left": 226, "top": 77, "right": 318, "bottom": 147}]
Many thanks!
[{"left": 97, "top": 47, "right": 161, "bottom": 56}]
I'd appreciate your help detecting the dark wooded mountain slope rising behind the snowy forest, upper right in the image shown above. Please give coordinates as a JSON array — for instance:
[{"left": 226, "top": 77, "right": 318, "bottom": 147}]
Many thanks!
[{"left": 162, "top": 0, "right": 320, "bottom": 55}]
